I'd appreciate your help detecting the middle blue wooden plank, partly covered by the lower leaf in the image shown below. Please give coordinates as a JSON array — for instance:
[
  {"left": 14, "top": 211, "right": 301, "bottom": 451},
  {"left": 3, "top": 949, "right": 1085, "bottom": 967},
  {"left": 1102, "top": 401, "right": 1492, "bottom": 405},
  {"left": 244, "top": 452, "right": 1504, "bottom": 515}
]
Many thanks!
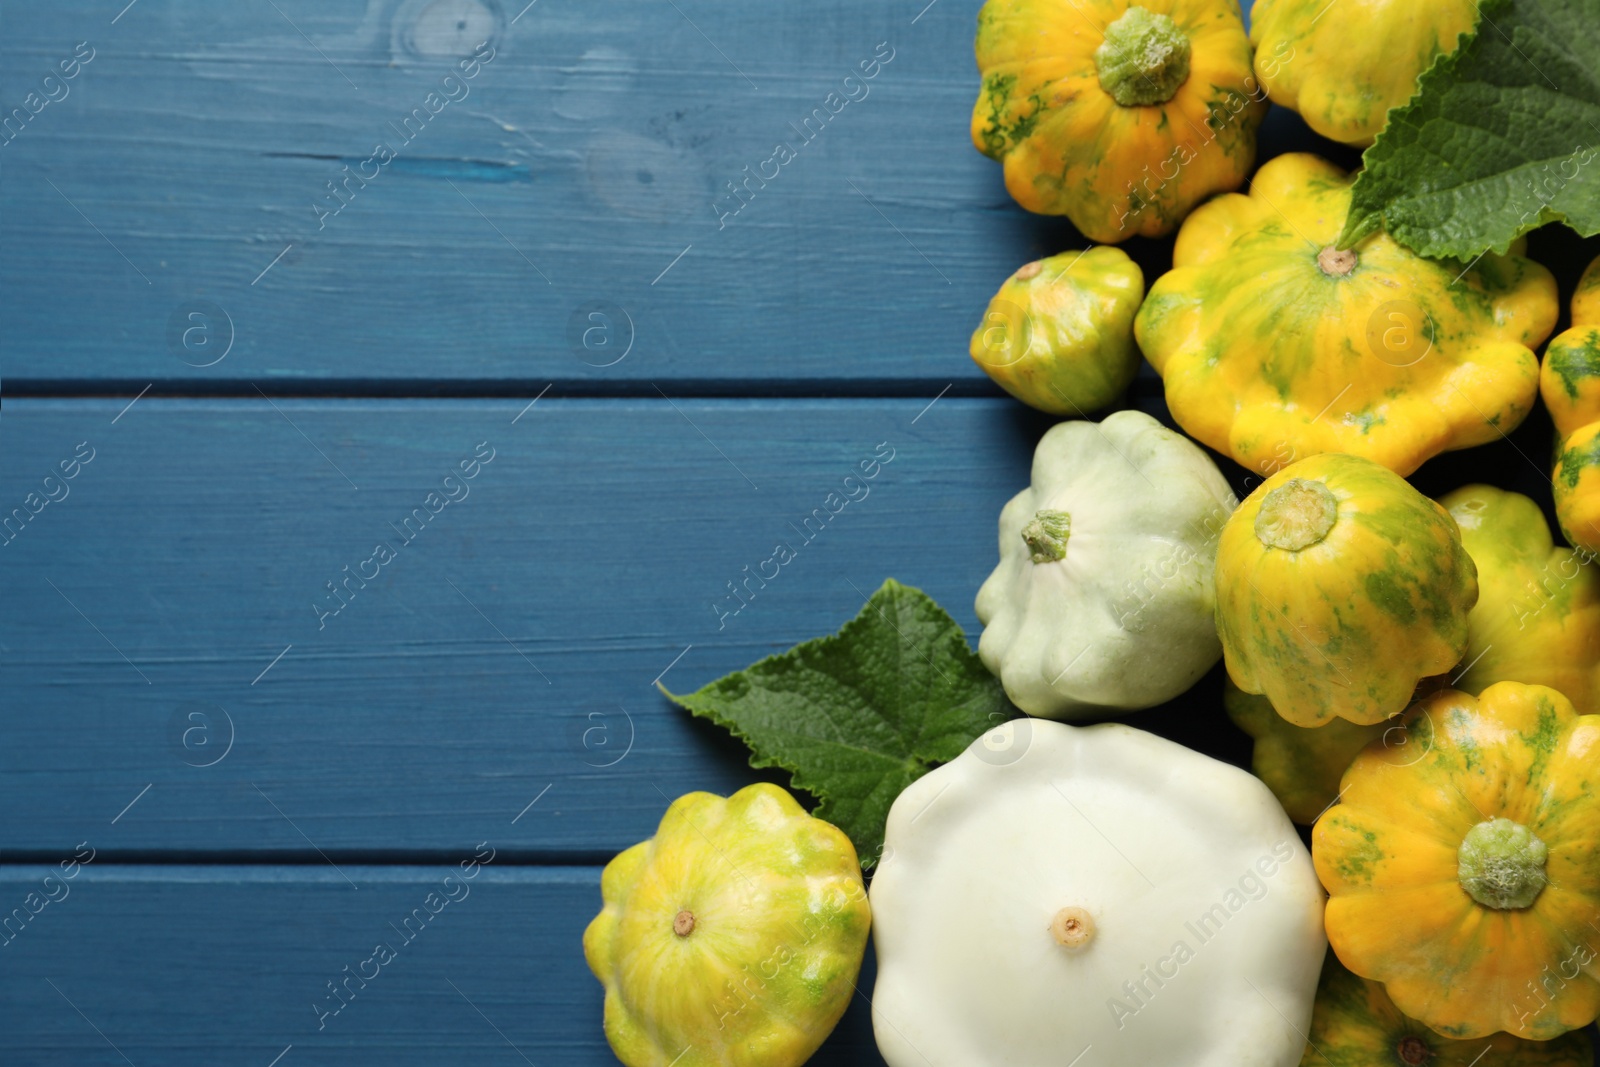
[{"left": 0, "top": 395, "right": 1549, "bottom": 859}]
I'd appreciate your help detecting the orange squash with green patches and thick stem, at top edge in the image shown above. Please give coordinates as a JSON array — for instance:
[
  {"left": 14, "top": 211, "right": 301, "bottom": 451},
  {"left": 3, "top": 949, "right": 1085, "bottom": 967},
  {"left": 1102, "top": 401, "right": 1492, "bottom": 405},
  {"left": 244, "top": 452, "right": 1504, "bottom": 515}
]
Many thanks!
[{"left": 973, "top": 0, "right": 1267, "bottom": 243}]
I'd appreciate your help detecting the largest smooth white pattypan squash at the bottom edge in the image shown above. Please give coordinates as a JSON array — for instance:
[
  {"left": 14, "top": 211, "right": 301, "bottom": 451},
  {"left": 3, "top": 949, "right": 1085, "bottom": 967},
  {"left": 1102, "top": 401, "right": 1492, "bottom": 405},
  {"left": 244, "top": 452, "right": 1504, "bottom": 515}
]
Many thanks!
[{"left": 872, "top": 718, "right": 1325, "bottom": 1067}]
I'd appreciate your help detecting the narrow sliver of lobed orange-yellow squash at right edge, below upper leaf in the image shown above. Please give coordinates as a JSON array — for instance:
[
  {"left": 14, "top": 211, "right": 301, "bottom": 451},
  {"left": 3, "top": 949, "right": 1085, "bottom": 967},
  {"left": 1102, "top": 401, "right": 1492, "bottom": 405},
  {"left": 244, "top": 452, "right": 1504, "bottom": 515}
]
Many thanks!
[{"left": 1539, "top": 259, "right": 1600, "bottom": 552}]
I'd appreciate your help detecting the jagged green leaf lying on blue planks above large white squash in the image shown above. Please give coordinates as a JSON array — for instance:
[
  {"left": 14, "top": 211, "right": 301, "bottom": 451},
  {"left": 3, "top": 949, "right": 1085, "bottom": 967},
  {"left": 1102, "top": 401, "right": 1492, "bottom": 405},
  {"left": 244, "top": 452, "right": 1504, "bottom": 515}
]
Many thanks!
[{"left": 656, "top": 577, "right": 1018, "bottom": 867}]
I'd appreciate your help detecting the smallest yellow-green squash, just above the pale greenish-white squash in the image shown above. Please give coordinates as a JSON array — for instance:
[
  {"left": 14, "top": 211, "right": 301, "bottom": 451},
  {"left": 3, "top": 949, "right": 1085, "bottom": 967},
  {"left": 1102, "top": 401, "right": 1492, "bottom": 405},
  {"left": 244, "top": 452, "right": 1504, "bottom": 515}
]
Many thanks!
[{"left": 971, "top": 245, "right": 1144, "bottom": 416}]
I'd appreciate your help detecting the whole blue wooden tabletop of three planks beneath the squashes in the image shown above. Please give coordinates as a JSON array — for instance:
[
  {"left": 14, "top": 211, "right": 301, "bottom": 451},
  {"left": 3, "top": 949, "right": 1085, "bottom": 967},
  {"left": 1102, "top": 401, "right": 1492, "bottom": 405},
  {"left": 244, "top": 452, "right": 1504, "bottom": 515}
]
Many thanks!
[{"left": 0, "top": 0, "right": 1597, "bottom": 1067}]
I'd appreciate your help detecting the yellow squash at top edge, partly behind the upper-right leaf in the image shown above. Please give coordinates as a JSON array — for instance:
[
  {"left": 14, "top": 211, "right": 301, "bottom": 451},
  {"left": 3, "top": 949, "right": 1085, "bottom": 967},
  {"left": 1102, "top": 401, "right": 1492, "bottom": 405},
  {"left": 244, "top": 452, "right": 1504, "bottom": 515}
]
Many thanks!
[{"left": 1250, "top": 0, "right": 1478, "bottom": 147}]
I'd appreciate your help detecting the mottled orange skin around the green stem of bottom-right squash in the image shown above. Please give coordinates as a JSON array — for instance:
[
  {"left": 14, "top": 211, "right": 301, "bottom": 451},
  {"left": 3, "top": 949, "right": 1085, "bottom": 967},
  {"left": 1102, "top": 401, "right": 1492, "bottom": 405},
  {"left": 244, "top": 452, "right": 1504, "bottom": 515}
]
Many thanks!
[{"left": 1312, "top": 681, "right": 1600, "bottom": 1048}]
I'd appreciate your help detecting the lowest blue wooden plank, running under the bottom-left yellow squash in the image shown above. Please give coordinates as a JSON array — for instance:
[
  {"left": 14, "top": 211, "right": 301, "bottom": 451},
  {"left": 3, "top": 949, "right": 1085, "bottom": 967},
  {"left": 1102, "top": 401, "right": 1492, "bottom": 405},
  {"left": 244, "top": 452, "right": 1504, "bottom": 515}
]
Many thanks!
[{"left": 0, "top": 863, "right": 882, "bottom": 1067}]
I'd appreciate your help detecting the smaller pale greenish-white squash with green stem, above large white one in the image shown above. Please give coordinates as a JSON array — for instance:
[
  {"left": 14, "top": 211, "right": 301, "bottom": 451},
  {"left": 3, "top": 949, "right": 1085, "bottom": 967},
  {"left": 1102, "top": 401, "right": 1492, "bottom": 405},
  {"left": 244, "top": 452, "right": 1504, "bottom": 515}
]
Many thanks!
[{"left": 978, "top": 411, "right": 1235, "bottom": 718}]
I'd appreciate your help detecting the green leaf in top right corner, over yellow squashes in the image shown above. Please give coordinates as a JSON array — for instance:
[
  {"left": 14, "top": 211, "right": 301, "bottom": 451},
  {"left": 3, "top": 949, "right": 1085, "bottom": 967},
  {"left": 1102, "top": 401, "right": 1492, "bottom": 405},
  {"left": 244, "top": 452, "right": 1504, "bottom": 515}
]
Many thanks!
[{"left": 1339, "top": 0, "right": 1600, "bottom": 259}]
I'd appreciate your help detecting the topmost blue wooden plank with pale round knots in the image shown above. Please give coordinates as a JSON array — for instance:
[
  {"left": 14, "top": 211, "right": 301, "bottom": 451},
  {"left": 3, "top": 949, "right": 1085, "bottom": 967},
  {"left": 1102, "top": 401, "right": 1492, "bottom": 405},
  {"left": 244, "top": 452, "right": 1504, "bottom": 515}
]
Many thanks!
[{"left": 0, "top": 0, "right": 1049, "bottom": 386}]
